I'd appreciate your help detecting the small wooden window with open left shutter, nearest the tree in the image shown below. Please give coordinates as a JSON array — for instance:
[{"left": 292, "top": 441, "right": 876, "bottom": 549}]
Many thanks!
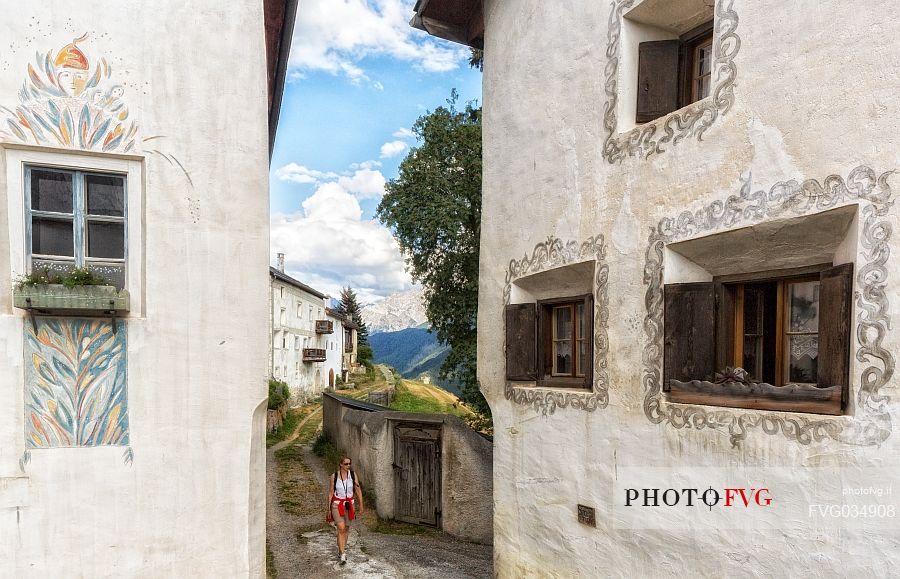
[{"left": 506, "top": 295, "right": 593, "bottom": 388}]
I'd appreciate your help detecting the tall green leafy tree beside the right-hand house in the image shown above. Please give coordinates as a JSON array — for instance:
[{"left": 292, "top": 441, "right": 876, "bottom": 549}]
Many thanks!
[{"left": 377, "top": 90, "right": 490, "bottom": 415}]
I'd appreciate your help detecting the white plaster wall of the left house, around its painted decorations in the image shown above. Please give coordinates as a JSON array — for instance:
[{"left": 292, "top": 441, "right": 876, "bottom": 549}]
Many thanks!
[{"left": 0, "top": 0, "right": 269, "bottom": 577}]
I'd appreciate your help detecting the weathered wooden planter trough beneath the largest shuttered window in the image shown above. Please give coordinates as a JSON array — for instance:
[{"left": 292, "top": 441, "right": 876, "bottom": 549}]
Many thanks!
[{"left": 666, "top": 380, "right": 843, "bottom": 416}]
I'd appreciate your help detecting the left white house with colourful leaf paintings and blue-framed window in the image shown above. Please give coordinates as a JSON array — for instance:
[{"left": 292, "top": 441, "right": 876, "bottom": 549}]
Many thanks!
[{"left": 0, "top": 0, "right": 297, "bottom": 577}]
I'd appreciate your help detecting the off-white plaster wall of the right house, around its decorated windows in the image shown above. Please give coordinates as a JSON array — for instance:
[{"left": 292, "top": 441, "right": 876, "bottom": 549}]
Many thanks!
[{"left": 478, "top": 0, "right": 900, "bottom": 577}]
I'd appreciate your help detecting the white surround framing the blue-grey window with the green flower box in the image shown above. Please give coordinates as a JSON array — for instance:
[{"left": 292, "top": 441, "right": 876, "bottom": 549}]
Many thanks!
[{"left": 0, "top": 143, "right": 145, "bottom": 318}]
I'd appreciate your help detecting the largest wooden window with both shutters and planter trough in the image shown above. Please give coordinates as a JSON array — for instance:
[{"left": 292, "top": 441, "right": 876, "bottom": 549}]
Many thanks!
[{"left": 664, "top": 264, "right": 853, "bottom": 414}]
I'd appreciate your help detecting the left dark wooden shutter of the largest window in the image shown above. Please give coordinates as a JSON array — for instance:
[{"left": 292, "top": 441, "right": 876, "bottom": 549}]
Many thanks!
[{"left": 663, "top": 283, "right": 716, "bottom": 390}]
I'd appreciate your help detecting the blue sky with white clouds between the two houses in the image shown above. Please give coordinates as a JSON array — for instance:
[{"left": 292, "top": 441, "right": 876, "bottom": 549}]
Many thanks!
[{"left": 270, "top": 0, "right": 481, "bottom": 302}]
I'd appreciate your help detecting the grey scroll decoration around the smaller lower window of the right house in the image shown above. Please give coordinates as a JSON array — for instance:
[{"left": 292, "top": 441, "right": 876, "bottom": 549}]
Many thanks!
[{"left": 503, "top": 235, "right": 609, "bottom": 415}]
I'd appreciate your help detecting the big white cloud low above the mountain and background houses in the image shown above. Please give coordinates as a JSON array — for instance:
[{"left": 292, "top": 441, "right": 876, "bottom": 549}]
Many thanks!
[{"left": 271, "top": 182, "right": 412, "bottom": 303}]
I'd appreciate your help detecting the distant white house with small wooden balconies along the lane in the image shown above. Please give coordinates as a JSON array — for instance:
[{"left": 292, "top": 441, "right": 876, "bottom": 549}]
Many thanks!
[{"left": 269, "top": 253, "right": 356, "bottom": 403}]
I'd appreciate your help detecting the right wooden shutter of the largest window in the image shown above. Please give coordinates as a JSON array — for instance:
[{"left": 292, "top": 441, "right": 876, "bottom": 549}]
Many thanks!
[{"left": 817, "top": 263, "right": 853, "bottom": 402}]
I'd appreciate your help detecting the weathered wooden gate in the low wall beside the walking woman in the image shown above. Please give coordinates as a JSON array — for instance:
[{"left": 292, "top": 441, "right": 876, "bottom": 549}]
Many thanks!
[{"left": 393, "top": 423, "right": 441, "bottom": 527}]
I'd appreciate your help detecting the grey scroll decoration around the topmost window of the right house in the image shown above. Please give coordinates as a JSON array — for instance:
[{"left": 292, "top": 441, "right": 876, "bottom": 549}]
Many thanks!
[{"left": 603, "top": 0, "right": 741, "bottom": 163}]
